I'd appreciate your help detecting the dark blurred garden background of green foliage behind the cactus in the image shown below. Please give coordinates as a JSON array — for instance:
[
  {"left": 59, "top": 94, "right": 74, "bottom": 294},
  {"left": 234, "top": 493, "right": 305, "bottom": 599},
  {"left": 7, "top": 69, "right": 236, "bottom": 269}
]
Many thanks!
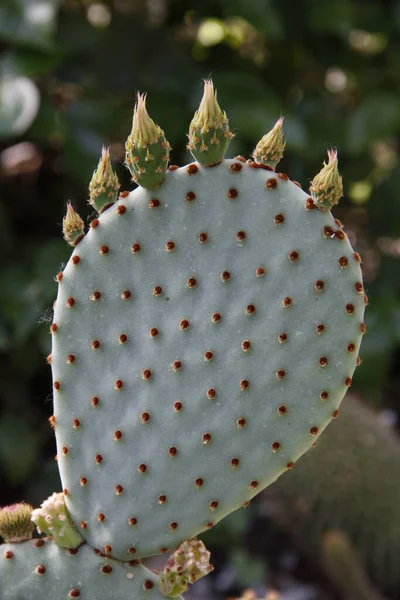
[{"left": 0, "top": 0, "right": 400, "bottom": 600}]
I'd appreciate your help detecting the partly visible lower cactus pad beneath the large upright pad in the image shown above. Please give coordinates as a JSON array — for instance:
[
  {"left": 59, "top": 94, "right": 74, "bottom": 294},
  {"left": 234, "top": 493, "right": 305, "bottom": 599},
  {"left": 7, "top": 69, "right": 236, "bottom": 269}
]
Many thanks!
[{"left": 0, "top": 539, "right": 172, "bottom": 600}]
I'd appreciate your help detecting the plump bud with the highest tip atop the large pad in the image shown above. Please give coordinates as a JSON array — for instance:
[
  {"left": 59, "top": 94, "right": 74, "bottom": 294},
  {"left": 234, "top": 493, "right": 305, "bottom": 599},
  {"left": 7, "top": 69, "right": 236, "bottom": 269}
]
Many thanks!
[{"left": 188, "top": 79, "right": 233, "bottom": 166}]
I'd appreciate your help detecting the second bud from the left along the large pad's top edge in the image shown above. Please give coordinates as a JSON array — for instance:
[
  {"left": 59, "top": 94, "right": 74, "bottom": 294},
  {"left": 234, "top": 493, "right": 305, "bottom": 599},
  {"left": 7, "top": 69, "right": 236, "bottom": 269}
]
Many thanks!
[{"left": 89, "top": 148, "right": 119, "bottom": 212}]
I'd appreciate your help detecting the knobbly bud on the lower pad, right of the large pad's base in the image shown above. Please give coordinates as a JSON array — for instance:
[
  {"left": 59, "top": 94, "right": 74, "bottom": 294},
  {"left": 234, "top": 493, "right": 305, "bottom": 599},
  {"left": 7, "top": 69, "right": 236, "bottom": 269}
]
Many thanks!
[{"left": 158, "top": 538, "right": 214, "bottom": 598}]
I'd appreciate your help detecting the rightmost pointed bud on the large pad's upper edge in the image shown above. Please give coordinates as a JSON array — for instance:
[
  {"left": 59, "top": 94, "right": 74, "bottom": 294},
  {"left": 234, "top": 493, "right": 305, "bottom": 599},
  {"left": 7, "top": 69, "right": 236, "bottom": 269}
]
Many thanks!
[{"left": 310, "top": 150, "right": 343, "bottom": 211}]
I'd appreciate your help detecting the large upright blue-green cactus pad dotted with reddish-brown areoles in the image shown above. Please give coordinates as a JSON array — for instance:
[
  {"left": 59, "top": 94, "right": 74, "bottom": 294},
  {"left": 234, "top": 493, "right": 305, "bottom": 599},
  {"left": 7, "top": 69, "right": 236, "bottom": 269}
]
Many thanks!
[{"left": 51, "top": 159, "right": 365, "bottom": 560}]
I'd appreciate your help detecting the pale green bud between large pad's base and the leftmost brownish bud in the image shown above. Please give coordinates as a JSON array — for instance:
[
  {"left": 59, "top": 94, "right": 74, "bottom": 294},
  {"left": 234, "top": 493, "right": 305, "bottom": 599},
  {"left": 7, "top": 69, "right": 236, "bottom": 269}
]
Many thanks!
[{"left": 32, "top": 492, "right": 83, "bottom": 548}]
